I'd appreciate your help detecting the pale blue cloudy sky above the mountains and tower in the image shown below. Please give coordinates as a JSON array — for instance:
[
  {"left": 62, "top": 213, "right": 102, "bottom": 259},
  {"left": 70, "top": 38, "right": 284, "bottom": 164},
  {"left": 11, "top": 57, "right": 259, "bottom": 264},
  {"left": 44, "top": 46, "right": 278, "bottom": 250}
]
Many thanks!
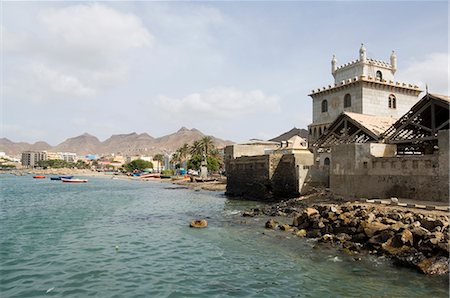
[{"left": 0, "top": 1, "right": 449, "bottom": 145}]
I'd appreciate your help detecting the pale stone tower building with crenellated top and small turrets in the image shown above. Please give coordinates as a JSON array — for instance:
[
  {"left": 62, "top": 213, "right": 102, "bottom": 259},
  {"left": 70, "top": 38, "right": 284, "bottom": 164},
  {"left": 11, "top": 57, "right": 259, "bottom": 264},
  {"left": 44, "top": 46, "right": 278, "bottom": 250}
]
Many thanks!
[{"left": 308, "top": 45, "right": 422, "bottom": 144}]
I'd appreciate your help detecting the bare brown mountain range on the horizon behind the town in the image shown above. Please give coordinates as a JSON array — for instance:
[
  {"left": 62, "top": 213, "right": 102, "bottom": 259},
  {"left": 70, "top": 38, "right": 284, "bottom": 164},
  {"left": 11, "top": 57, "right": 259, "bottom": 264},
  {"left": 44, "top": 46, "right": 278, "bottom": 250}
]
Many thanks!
[{"left": 0, "top": 127, "right": 233, "bottom": 156}]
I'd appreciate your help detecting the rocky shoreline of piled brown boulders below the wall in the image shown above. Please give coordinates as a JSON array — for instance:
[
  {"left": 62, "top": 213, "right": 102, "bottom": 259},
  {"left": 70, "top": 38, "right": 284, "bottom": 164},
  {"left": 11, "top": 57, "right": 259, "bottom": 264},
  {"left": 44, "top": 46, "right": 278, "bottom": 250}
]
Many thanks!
[{"left": 243, "top": 194, "right": 450, "bottom": 275}]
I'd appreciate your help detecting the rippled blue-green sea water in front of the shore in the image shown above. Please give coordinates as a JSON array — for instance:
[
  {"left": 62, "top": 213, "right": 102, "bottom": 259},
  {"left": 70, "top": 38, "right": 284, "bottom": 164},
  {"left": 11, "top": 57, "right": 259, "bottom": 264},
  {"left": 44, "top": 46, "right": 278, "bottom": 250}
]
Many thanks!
[{"left": 0, "top": 174, "right": 449, "bottom": 298}]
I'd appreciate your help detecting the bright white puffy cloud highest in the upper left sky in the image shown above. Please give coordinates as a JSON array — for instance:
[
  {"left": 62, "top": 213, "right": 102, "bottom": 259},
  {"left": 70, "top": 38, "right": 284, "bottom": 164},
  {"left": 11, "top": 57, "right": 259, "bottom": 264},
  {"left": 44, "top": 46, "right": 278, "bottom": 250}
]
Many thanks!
[{"left": 39, "top": 4, "right": 153, "bottom": 56}]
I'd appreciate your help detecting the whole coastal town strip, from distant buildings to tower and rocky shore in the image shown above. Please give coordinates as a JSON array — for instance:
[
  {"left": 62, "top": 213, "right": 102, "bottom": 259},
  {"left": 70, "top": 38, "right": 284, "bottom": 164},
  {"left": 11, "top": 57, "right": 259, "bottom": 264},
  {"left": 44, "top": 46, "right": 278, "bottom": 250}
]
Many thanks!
[{"left": 1, "top": 45, "right": 450, "bottom": 275}]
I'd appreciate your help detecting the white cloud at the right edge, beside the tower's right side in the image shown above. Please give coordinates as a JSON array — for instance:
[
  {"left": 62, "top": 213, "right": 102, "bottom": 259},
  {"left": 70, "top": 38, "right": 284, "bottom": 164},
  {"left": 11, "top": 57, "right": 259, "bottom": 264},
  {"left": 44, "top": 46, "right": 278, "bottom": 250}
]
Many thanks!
[{"left": 398, "top": 53, "right": 450, "bottom": 94}]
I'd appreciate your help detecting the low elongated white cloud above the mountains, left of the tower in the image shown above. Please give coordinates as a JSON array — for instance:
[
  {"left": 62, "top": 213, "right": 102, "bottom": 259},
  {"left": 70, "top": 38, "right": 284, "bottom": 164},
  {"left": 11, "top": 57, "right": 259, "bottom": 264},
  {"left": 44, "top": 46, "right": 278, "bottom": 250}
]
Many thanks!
[{"left": 154, "top": 87, "right": 281, "bottom": 120}]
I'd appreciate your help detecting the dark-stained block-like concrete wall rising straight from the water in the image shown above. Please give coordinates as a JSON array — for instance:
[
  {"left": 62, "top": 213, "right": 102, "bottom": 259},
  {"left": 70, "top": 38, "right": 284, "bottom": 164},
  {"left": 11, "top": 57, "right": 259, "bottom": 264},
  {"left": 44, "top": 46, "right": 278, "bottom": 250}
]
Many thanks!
[{"left": 226, "top": 153, "right": 313, "bottom": 200}]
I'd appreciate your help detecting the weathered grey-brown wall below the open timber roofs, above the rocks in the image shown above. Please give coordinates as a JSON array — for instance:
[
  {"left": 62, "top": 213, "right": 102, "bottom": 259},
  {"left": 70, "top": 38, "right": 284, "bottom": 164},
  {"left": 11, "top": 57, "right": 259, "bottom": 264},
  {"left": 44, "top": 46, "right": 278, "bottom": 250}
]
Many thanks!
[{"left": 330, "top": 131, "right": 449, "bottom": 201}]
